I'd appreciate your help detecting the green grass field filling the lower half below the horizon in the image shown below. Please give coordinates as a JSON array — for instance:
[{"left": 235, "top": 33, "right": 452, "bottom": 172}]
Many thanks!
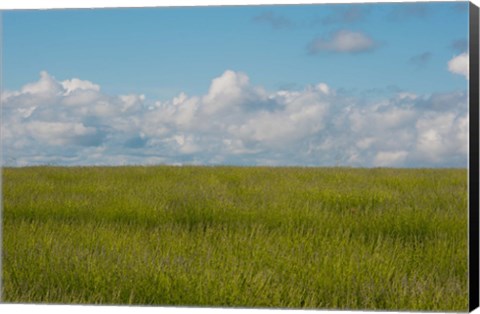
[{"left": 2, "top": 166, "right": 468, "bottom": 311}]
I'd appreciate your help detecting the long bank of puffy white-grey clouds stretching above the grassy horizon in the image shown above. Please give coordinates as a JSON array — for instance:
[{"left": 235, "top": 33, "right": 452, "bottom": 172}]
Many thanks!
[{"left": 1, "top": 70, "right": 468, "bottom": 167}]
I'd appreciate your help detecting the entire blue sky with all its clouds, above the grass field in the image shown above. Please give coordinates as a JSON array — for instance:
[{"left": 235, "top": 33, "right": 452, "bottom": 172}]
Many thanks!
[{"left": 2, "top": 3, "right": 468, "bottom": 167}]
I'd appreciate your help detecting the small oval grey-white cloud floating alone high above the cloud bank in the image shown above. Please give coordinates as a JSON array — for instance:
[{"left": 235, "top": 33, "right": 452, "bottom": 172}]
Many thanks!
[{"left": 307, "top": 30, "right": 378, "bottom": 54}]
